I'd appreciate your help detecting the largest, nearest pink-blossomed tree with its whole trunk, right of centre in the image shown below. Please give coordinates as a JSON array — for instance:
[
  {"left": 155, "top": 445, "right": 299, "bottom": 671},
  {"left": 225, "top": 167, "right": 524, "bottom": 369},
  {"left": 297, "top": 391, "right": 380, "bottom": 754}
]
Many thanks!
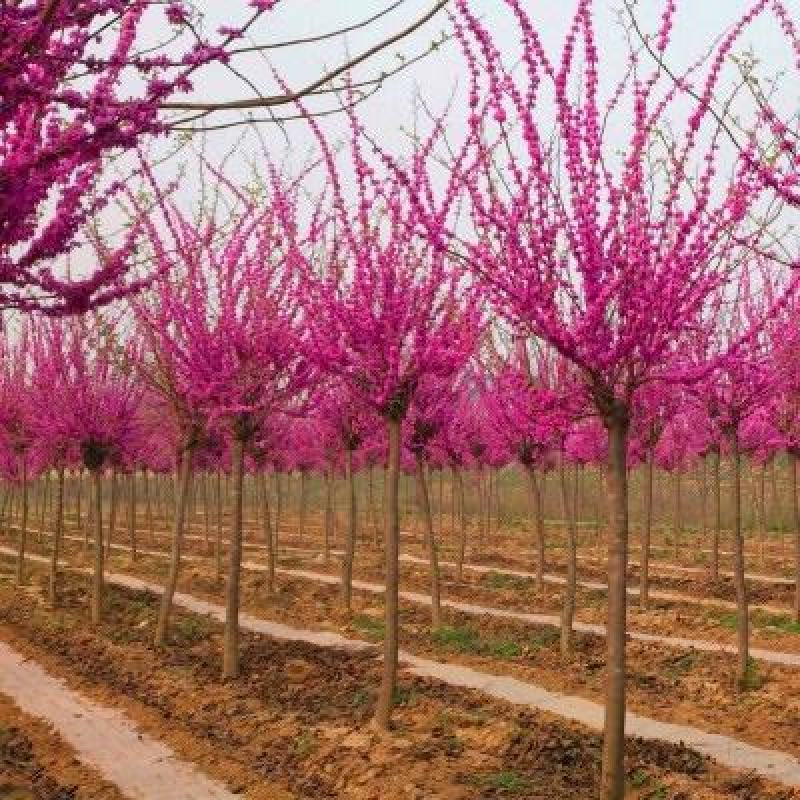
[{"left": 394, "top": 0, "right": 792, "bottom": 798}]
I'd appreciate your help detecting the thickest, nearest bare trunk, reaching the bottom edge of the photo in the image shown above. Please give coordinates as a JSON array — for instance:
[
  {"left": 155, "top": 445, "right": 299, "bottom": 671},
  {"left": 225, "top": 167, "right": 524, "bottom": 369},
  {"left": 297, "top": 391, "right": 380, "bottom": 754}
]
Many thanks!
[{"left": 601, "top": 409, "right": 628, "bottom": 800}]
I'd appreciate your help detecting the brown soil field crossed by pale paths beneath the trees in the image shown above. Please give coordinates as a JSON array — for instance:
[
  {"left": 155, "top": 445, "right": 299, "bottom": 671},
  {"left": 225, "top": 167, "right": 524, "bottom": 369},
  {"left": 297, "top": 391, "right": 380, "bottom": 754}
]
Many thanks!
[{"left": 0, "top": 465, "right": 800, "bottom": 799}]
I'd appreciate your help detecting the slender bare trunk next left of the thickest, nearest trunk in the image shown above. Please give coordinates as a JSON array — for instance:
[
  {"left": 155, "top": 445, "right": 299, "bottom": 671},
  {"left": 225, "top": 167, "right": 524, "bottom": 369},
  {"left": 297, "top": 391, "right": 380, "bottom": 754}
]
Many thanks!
[{"left": 373, "top": 419, "right": 401, "bottom": 731}]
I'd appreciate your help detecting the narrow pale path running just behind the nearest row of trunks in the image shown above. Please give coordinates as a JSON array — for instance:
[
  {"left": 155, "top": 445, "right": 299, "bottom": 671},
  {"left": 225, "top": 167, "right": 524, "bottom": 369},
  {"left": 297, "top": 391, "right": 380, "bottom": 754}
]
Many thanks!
[{"left": 0, "top": 548, "right": 800, "bottom": 788}]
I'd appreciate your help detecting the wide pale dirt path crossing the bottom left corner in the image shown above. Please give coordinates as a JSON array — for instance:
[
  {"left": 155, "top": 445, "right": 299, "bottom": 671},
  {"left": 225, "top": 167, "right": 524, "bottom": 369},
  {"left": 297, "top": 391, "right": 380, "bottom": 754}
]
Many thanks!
[{"left": 0, "top": 642, "right": 241, "bottom": 800}]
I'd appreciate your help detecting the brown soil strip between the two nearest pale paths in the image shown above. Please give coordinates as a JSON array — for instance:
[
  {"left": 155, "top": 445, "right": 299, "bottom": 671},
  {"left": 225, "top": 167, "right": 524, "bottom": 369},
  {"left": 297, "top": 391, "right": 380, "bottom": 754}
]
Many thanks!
[{"left": 0, "top": 568, "right": 800, "bottom": 800}]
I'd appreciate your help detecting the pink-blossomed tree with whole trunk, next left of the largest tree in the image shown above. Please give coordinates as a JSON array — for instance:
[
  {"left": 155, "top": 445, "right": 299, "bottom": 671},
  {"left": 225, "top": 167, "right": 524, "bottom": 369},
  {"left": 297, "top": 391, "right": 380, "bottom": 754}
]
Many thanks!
[{"left": 303, "top": 100, "right": 481, "bottom": 729}]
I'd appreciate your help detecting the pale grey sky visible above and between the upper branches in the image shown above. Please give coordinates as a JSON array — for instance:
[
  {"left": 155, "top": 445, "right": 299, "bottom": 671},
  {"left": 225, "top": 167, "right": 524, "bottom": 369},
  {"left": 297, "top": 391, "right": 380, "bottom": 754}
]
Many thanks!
[{"left": 138, "top": 0, "right": 800, "bottom": 204}]
